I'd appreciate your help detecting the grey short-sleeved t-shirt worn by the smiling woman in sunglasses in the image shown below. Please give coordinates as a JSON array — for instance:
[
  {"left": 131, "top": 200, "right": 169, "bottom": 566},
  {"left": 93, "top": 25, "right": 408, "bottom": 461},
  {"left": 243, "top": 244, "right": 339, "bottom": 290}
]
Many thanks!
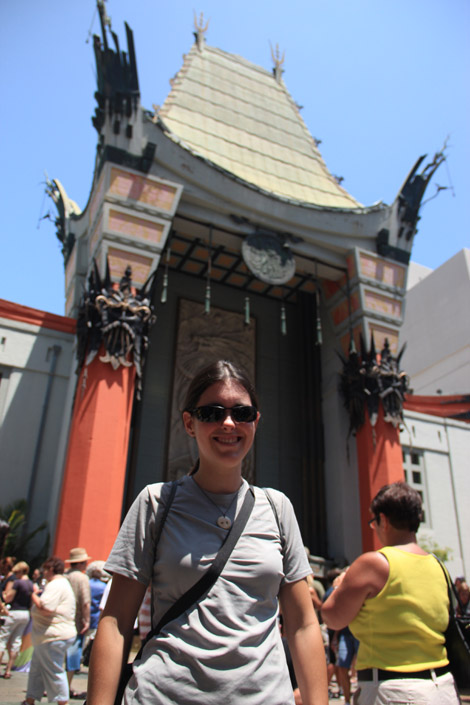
[{"left": 105, "top": 476, "right": 311, "bottom": 705}]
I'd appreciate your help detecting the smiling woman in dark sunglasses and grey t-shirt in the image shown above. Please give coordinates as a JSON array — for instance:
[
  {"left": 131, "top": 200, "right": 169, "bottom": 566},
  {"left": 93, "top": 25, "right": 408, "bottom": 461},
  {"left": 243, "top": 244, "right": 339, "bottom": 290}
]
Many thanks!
[{"left": 87, "top": 361, "right": 328, "bottom": 705}]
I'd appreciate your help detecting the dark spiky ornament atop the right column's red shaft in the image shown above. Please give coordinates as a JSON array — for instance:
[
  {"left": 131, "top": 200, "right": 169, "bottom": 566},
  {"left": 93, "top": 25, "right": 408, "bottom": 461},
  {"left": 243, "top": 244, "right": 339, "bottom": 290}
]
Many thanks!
[{"left": 340, "top": 336, "right": 410, "bottom": 435}]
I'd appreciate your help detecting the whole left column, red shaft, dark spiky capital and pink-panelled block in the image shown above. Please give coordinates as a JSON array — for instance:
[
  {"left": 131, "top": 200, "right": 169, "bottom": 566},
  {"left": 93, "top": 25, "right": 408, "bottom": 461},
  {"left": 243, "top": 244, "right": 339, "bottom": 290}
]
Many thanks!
[{"left": 54, "top": 161, "right": 183, "bottom": 560}]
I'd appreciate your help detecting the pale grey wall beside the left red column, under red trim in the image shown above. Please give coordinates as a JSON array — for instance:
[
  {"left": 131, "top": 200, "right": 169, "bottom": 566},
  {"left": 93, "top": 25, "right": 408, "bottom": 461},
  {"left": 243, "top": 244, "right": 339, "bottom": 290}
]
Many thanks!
[{"left": 0, "top": 308, "right": 75, "bottom": 544}]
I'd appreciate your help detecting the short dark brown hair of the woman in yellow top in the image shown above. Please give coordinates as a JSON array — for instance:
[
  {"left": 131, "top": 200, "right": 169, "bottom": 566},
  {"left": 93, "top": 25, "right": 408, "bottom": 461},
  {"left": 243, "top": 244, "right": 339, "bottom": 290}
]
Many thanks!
[{"left": 370, "top": 482, "right": 423, "bottom": 532}]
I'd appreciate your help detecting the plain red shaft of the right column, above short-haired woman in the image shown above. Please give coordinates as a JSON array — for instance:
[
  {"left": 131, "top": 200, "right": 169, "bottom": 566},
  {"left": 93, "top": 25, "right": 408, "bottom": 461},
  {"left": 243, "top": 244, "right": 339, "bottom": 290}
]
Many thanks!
[{"left": 356, "top": 404, "right": 405, "bottom": 551}]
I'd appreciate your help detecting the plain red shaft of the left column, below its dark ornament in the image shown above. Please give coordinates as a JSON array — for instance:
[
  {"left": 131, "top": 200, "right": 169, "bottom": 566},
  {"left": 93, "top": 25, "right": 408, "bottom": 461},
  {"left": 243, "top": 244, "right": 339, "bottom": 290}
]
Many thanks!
[{"left": 54, "top": 351, "right": 135, "bottom": 560}]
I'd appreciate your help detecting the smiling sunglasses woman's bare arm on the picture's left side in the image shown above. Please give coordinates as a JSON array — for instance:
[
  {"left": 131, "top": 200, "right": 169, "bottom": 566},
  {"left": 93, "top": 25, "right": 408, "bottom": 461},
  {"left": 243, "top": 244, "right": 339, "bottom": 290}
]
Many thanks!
[{"left": 87, "top": 574, "right": 146, "bottom": 705}]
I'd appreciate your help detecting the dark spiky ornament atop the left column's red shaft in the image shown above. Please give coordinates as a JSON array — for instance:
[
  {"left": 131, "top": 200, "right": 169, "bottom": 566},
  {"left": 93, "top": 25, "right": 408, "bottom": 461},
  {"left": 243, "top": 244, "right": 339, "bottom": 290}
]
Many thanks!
[{"left": 77, "top": 261, "right": 156, "bottom": 399}]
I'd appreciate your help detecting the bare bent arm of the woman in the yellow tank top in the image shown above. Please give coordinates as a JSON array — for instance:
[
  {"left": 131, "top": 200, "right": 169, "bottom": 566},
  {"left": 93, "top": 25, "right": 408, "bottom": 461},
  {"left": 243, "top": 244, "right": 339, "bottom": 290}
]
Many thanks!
[{"left": 321, "top": 551, "right": 389, "bottom": 629}]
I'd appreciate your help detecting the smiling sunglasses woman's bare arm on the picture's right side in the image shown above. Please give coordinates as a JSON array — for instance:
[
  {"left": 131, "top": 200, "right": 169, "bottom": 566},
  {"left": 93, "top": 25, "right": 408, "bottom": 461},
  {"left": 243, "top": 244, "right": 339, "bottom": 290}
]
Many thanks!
[{"left": 280, "top": 580, "right": 328, "bottom": 705}]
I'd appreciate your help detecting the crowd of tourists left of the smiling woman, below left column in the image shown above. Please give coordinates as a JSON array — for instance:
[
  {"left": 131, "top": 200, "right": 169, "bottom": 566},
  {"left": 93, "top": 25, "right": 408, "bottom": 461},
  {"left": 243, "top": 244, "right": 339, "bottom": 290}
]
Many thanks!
[{"left": 0, "top": 548, "right": 110, "bottom": 705}]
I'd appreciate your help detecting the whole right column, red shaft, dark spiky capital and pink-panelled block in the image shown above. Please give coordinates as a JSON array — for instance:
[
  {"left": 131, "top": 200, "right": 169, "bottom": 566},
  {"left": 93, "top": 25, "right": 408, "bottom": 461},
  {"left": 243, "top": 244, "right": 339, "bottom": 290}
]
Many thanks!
[{"left": 324, "top": 248, "right": 407, "bottom": 551}]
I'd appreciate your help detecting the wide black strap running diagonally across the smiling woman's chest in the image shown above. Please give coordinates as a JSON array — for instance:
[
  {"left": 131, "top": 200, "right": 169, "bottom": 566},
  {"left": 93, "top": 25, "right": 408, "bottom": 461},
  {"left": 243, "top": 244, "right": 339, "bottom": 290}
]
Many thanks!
[{"left": 136, "top": 486, "right": 255, "bottom": 659}]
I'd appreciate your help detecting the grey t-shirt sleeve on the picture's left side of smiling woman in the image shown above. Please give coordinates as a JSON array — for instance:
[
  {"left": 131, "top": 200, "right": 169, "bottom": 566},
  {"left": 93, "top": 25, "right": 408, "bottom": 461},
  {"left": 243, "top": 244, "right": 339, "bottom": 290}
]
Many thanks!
[{"left": 104, "top": 482, "right": 165, "bottom": 585}]
